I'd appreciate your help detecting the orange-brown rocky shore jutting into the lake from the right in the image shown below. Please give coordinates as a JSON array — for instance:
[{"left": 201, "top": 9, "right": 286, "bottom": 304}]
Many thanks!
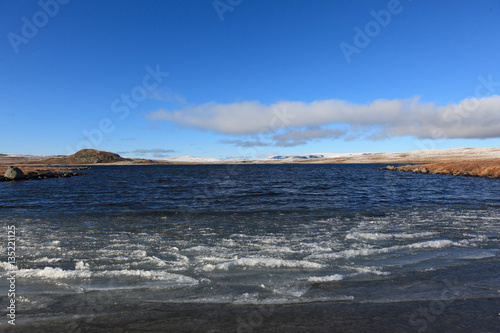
[{"left": 379, "top": 160, "right": 500, "bottom": 179}]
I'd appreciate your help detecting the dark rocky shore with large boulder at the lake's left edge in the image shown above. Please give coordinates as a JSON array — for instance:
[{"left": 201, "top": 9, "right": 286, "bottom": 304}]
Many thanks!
[{"left": 0, "top": 166, "right": 89, "bottom": 182}]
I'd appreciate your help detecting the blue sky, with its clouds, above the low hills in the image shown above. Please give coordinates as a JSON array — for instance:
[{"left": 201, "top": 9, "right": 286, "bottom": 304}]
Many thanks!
[{"left": 0, "top": 0, "right": 500, "bottom": 158}]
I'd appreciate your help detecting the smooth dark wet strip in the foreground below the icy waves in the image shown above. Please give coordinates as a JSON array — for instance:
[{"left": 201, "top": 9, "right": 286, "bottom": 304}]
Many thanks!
[{"left": 4, "top": 296, "right": 500, "bottom": 332}]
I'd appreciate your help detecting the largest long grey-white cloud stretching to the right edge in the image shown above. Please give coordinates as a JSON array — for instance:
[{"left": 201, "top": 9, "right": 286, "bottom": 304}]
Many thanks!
[{"left": 147, "top": 95, "right": 500, "bottom": 140}]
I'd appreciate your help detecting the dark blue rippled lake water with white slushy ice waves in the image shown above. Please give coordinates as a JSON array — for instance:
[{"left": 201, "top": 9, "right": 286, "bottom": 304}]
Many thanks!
[{"left": 0, "top": 165, "right": 500, "bottom": 326}]
